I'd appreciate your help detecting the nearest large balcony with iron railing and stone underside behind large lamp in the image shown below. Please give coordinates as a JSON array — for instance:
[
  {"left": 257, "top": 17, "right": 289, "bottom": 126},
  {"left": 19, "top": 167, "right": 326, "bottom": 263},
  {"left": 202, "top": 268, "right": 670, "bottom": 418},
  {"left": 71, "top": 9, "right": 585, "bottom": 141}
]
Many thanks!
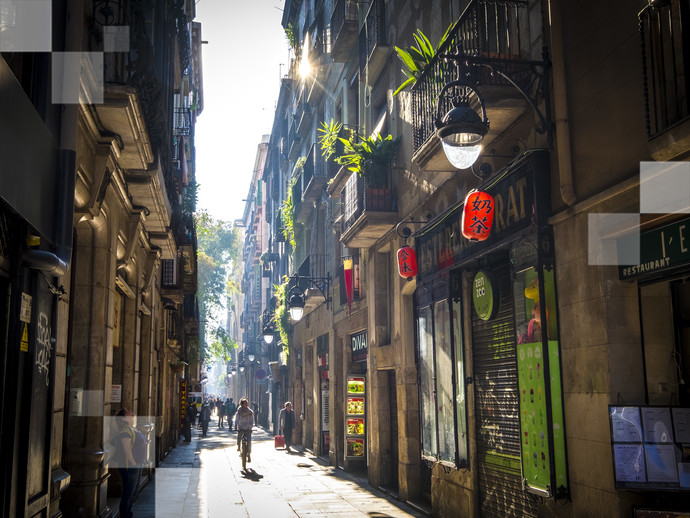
[{"left": 412, "top": 0, "right": 543, "bottom": 170}]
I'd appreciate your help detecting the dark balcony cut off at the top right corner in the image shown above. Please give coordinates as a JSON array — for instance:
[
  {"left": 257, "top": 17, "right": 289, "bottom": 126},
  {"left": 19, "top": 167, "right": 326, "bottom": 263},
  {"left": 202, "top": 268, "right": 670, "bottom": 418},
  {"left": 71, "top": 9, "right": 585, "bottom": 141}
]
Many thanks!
[{"left": 639, "top": 0, "right": 690, "bottom": 161}]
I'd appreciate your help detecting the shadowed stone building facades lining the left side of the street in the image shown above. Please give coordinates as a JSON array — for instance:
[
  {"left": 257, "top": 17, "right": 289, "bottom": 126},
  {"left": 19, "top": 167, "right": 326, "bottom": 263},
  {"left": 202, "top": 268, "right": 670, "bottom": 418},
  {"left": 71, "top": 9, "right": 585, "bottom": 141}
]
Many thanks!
[{"left": 0, "top": 0, "right": 203, "bottom": 517}]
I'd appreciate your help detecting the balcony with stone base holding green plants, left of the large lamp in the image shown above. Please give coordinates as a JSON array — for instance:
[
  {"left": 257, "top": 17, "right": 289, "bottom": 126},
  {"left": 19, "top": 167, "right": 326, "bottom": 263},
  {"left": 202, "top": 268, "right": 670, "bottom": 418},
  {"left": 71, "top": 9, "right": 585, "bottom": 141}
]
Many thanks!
[{"left": 340, "top": 167, "right": 398, "bottom": 248}]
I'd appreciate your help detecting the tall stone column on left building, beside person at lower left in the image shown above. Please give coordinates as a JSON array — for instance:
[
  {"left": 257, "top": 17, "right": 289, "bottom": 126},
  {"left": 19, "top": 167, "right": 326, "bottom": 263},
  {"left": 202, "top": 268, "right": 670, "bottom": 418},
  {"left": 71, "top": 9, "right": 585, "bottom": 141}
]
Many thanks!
[{"left": 64, "top": 215, "right": 115, "bottom": 516}]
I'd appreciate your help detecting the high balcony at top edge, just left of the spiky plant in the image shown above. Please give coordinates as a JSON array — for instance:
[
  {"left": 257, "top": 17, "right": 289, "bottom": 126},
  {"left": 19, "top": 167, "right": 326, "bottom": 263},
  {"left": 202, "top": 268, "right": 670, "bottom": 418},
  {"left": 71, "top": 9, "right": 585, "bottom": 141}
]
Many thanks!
[{"left": 359, "top": 0, "right": 390, "bottom": 85}]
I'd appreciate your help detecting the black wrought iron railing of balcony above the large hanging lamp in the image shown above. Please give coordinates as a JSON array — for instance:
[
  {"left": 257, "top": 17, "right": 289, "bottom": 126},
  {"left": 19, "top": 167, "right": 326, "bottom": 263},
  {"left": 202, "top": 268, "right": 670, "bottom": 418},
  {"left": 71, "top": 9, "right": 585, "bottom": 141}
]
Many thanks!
[{"left": 412, "top": 0, "right": 541, "bottom": 153}]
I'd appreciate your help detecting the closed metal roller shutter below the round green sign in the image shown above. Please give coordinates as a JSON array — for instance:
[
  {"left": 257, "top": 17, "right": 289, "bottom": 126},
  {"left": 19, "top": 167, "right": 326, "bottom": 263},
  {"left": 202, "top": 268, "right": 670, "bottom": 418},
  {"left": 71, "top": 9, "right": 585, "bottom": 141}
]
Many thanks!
[{"left": 472, "top": 264, "right": 537, "bottom": 518}]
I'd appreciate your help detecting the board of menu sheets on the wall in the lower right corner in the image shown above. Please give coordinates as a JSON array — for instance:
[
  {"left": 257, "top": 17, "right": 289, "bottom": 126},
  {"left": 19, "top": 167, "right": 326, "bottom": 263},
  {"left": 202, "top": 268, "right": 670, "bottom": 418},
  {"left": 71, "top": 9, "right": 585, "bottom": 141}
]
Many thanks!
[{"left": 609, "top": 405, "right": 690, "bottom": 490}]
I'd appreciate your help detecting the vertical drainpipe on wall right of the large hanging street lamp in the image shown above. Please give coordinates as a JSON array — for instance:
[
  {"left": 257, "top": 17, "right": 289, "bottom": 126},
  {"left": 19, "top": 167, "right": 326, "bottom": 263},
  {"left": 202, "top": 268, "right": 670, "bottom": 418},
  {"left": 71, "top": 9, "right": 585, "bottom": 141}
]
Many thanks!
[{"left": 548, "top": 0, "right": 577, "bottom": 206}]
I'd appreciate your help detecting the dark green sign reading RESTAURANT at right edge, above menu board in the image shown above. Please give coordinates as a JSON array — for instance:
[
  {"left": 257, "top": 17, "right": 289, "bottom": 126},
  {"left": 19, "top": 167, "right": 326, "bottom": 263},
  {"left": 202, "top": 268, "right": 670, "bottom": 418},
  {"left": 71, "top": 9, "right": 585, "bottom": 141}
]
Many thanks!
[{"left": 618, "top": 218, "right": 690, "bottom": 280}]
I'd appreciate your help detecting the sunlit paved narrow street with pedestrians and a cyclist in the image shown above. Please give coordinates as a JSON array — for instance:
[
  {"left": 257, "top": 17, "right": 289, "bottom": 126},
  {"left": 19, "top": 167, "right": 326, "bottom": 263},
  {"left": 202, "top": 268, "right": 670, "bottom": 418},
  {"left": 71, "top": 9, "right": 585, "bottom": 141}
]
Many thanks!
[{"left": 128, "top": 417, "right": 424, "bottom": 518}]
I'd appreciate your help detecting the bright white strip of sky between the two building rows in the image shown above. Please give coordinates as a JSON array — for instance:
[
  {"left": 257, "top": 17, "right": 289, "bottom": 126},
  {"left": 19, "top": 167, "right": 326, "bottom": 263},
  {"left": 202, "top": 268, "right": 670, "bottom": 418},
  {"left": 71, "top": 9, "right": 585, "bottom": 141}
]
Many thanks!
[{"left": 195, "top": 0, "right": 290, "bottom": 225}]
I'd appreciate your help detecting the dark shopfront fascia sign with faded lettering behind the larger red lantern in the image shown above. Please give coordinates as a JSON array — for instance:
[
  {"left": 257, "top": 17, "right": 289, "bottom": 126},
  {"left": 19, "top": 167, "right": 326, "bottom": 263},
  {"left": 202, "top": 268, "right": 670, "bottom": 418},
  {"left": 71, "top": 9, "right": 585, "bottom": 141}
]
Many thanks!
[{"left": 417, "top": 152, "right": 548, "bottom": 279}]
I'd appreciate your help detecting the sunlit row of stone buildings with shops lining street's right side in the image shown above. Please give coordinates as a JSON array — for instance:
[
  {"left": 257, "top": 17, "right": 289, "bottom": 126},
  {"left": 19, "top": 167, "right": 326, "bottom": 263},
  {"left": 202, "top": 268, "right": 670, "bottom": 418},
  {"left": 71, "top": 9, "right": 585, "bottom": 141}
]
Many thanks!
[{"left": 241, "top": 0, "right": 689, "bottom": 516}]
